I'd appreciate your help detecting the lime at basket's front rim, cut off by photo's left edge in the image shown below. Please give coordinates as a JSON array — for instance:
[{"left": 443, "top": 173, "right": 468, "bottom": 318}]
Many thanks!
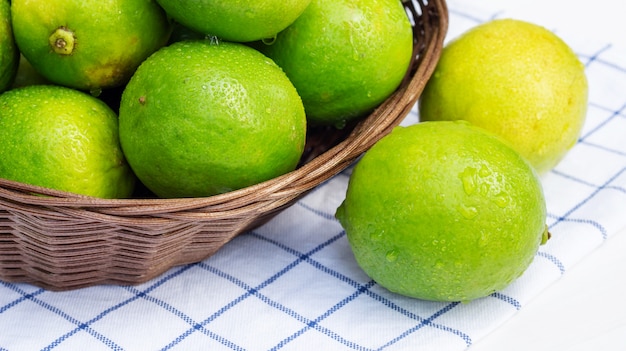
[{"left": 0, "top": 85, "right": 135, "bottom": 198}]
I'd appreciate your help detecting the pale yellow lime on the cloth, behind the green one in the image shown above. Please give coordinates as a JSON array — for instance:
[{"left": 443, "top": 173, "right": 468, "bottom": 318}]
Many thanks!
[{"left": 420, "top": 19, "right": 588, "bottom": 174}]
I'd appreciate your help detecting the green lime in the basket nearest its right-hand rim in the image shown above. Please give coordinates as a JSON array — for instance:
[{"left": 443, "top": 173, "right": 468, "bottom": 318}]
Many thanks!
[{"left": 260, "top": 0, "right": 413, "bottom": 127}]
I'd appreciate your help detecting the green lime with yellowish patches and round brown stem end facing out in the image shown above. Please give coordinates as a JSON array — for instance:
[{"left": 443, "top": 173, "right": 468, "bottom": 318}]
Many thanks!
[{"left": 11, "top": 0, "right": 171, "bottom": 92}]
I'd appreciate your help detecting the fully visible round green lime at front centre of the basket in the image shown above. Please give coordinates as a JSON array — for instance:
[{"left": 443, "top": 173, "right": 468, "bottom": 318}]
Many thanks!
[{"left": 120, "top": 40, "right": 306, "bottom": 197}]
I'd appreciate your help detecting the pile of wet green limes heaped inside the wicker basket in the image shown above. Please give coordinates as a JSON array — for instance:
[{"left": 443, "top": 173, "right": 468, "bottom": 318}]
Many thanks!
[{"left": 0, "top": 0, "right": 413, "bottom": 197}]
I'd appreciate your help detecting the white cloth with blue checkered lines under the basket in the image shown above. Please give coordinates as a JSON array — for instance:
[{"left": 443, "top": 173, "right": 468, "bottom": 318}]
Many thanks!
[{"left": 0, "top": 0, "right": 626, "bottom": 351}]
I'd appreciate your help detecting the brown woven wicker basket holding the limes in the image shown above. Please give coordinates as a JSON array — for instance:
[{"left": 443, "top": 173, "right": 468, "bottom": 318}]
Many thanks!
[{"left": 0, "top": 0, "right": 448, "bottom": 290}]
